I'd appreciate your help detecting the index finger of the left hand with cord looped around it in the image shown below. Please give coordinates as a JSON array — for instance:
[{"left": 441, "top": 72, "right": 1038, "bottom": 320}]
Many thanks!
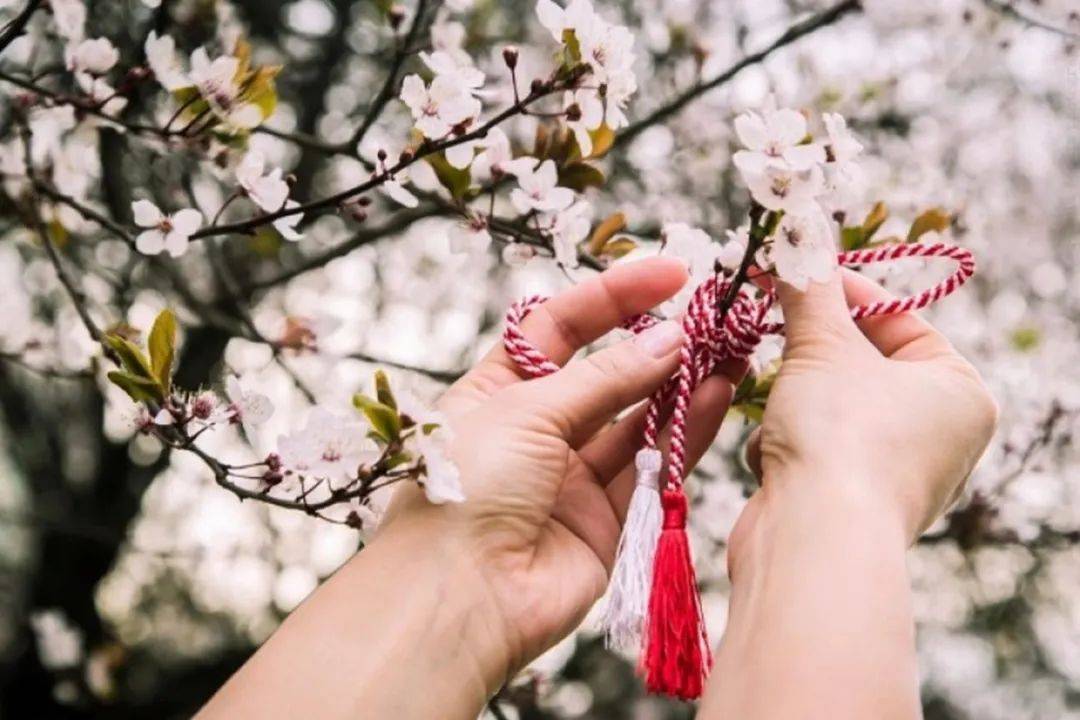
[{"left": 441, "top": 257, "right": 687, "bottom": 410}]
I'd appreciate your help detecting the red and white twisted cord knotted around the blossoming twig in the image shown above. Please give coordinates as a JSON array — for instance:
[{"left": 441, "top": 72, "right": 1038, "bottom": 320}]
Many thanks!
[{"left": 502, "top": 243, "right": 975, "bottom": 489}]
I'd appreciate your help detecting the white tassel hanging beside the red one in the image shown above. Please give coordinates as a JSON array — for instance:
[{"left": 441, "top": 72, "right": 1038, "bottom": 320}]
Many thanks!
[{"left": 600, "top": 448, "right": 663, "bottom": 652}]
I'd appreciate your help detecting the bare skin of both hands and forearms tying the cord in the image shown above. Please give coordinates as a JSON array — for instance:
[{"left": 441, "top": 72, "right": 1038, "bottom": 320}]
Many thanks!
[{"left": 201, "top": 258, "right": 993, "bottom": 719}]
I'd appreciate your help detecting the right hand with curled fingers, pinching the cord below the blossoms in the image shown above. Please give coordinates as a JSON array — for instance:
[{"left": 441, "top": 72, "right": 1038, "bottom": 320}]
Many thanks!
[{"left": 730, "top": 271, "right": 997, "bottom": 562}]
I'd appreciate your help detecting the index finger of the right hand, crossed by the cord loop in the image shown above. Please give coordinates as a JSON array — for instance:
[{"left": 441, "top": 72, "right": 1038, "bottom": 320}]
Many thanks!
[{"left": 843, "top": 270, "right": 953, "bottom": 361}]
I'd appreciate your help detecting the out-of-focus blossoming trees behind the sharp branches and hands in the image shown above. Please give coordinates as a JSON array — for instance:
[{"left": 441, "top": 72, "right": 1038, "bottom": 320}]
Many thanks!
[{"left": 0, "top": 0, "right": 1080, "bottom": 720}]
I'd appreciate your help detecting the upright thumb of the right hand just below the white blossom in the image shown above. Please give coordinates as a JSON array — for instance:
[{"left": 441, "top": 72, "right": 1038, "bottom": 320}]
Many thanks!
[{"left": 777, "top": 271, "right": 859, "bottom": 356}]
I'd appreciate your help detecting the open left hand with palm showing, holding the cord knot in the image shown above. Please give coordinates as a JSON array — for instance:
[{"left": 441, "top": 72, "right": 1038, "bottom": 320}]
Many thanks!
[{"left": 372, "top": 258, "right": 740, "bottom": 691}]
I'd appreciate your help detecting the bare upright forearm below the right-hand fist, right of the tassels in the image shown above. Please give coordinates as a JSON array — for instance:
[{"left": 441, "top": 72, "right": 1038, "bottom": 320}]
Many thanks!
[{"left": 700, "top": 476, "right": 920, "bottom": 720}]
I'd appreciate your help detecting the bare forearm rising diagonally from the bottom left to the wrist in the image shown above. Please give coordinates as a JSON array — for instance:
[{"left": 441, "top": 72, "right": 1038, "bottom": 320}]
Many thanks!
[{"left": 201, "top": 527, "right": 505, "bottom": 720}]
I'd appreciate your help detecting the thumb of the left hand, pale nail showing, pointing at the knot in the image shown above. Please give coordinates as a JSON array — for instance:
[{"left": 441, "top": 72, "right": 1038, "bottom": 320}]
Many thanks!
[{"left": 522, "top": 321, "right": 683, "bottom": 447}]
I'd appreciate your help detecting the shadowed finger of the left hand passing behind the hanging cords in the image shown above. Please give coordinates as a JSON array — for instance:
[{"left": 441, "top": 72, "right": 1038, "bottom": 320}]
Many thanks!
[{"left": 607, "top": 376, "right": 734, "bottom": 524}]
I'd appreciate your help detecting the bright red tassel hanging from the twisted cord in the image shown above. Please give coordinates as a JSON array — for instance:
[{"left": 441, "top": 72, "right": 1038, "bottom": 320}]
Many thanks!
[{"left": 642, "top": 487, "right": 713, "bottom": 699}]
